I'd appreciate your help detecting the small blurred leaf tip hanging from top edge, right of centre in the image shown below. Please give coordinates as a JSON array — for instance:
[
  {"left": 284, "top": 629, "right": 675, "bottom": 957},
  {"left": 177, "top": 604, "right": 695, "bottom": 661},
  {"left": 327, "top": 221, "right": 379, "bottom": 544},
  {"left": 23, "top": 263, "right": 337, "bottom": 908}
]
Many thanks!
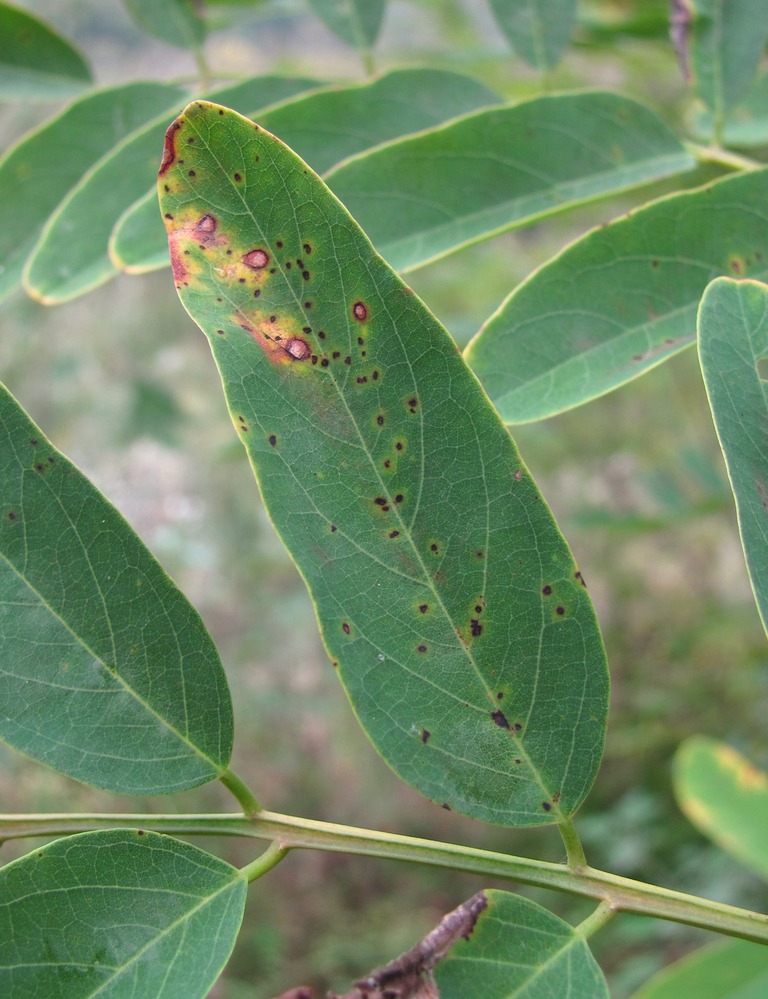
[{"left": 490, "top": 0, "right": 576, "bottom": 70}]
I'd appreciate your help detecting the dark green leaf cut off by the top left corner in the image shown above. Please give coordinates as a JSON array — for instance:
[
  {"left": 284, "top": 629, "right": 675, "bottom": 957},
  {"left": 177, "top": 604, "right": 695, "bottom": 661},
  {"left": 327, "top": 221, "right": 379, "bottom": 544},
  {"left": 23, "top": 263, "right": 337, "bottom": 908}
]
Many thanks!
[{"left": 0, "top": 3, "right": 91, "bottom": 101}]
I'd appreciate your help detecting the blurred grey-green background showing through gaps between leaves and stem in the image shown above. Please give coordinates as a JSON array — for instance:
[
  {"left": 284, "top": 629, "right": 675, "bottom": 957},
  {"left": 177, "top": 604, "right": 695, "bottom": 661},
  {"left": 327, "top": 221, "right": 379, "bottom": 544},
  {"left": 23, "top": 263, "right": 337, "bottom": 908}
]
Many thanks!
[{"left": 0, "top": 0, "right": 768, "bottom": 999}]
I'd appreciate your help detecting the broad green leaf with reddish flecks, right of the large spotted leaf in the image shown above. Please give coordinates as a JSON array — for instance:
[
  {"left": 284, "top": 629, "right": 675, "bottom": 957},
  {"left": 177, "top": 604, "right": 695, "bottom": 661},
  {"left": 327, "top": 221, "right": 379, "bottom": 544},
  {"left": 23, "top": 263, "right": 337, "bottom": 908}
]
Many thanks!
[{"left": 464, "top": 170, "right": 768, "bottom": 423}]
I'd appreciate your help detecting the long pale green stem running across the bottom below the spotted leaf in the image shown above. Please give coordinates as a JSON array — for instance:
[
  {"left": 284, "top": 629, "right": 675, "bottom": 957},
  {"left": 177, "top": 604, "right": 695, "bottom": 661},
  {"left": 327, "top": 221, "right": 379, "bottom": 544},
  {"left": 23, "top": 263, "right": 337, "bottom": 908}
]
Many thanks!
[{"left": 0, "top": 811, "right": 768, "bottom": 944}]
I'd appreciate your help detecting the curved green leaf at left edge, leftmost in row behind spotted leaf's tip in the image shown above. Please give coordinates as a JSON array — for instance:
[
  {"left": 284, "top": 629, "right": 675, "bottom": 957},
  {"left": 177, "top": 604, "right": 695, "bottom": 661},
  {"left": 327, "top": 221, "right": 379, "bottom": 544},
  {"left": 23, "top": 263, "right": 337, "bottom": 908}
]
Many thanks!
[{"left": 0, "top": 83, "right": 183, "bottom": 301}]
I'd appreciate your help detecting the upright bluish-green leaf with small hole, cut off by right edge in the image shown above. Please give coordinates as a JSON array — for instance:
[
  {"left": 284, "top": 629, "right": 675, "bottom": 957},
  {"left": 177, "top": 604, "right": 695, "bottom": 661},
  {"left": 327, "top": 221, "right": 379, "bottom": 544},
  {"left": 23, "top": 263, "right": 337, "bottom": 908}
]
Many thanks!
[{"left": 698, "top": 278, "right": 768, "bottom": 630}]
